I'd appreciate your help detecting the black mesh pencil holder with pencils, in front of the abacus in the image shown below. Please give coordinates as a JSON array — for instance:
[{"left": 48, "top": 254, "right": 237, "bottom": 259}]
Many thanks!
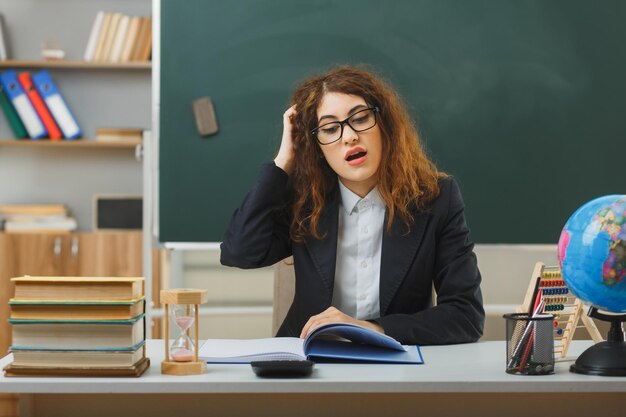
[{"left": 504, "top": 313, "right": 554, "bottom": 375}]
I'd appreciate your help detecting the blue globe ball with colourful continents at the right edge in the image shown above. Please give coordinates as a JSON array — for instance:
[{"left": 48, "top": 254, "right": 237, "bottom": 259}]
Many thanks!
[{"left": 558, "top": 195, "right": 626, "bottom": 313}]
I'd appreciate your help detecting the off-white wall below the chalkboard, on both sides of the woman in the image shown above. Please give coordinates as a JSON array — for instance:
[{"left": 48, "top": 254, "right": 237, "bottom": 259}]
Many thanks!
[{"left": 172, "top": 245, "right": 557, "bottom": 340}]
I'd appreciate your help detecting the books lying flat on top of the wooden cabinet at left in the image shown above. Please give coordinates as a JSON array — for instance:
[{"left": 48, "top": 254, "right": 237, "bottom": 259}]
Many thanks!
[{"left": 0, "top": 204, "right": 78, "bottom": 233}]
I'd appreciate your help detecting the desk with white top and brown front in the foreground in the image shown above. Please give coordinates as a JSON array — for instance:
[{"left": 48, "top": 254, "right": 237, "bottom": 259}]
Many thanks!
[{"left": 0, "top": 340, "right": 626, "bottom": 417}]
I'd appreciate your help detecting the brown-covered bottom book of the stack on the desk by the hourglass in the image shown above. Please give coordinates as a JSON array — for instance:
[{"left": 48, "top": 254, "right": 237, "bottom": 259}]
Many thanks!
[{"left": 4, "top": 357, "right": 150, "bottom": 377}]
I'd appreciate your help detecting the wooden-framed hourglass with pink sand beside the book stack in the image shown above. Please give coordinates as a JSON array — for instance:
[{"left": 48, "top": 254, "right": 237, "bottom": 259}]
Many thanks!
[{"left": 161, "top": 288, "right": 209, "bottom": 375}]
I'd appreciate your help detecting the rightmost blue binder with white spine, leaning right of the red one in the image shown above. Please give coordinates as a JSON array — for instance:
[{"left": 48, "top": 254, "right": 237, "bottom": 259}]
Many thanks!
[{"left": 32, "top": 70, "right": 82, "bottom": 139}]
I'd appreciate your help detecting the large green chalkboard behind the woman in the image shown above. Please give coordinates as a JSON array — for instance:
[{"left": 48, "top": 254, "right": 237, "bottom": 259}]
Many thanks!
[{"left": 159, "top": 0, "right": 626, "bottom": 243}]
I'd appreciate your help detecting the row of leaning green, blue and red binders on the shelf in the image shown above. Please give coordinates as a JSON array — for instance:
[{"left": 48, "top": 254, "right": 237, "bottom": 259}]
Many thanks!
[{"left": 0, "top": 70, "right": 82, "bottom": 140}]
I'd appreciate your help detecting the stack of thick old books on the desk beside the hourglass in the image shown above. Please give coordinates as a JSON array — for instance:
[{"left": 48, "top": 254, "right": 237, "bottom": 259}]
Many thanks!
[{"left": 4, "top": 276, "right": 150, "bottom": 376}]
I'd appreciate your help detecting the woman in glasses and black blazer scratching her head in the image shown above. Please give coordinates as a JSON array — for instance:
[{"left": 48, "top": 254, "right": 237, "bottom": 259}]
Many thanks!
[{"left": 221, "top": 67, "right": 484, "bottom": 345}]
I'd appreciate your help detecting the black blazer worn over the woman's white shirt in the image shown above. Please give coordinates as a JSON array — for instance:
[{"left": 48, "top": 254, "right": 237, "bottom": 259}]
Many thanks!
[{"left": 221, "top": 163, "right": 485, "bottom": 345}]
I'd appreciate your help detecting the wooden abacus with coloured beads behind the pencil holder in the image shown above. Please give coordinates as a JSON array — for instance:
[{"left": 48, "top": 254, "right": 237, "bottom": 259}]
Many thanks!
[{"left": 517, "top": 262, "right": 603, "bottom": 358}]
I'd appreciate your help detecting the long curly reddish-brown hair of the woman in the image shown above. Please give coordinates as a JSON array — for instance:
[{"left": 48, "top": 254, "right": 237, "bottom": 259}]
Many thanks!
[{"left": 290, "top": 66, "right": 446, "bottom": 242}]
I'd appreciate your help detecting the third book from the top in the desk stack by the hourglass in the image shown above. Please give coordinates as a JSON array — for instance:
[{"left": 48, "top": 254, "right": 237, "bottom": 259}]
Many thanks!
[{"left": 9, "top": 314, "right": 145, "bottom": 351}]
